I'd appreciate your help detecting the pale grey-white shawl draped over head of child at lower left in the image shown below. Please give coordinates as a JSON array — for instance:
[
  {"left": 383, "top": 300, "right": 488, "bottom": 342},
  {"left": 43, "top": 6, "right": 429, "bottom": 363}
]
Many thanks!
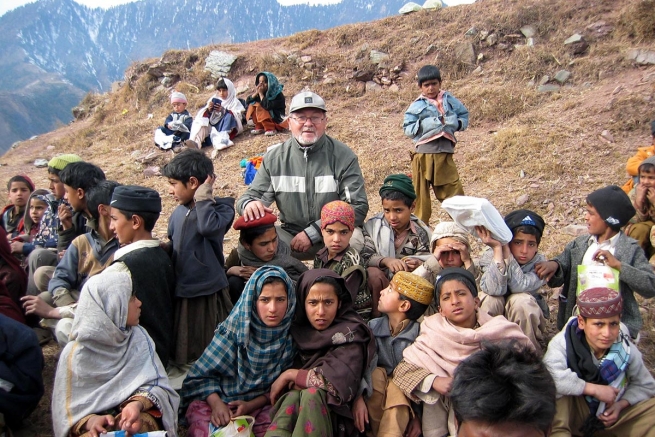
[{"left": 52, "top": 271, "right": 179, "bottom": 437}]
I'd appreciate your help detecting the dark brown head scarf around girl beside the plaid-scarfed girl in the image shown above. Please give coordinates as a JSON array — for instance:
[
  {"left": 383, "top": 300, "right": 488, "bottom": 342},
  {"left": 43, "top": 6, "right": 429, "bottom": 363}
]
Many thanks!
[{"left": 291, "top": 269, "right": 376, "bottom": 417}]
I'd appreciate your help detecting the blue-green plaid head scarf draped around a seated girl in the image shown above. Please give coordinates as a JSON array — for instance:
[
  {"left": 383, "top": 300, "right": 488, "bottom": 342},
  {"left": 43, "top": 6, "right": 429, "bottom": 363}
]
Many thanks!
[{"left": 180, "top": 266, "right": 296, "bottom": 412}]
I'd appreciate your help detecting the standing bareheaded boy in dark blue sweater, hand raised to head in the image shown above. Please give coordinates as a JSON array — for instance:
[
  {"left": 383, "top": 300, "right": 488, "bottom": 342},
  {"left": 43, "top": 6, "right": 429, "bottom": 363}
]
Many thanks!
[{"left": 163, "top": 149, "right": 234, "bottom": 366}]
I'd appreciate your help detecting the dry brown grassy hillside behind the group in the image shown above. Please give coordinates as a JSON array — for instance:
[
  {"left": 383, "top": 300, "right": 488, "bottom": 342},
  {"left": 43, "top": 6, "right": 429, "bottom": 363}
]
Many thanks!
[{"left": 5, "top": 0, "right": 655, "bottom": 435}]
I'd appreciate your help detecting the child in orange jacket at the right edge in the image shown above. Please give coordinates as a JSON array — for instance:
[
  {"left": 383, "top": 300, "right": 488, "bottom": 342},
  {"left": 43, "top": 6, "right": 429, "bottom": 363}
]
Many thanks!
[{"left": 625, "top": 156, "right": 655, "bottom": 264}]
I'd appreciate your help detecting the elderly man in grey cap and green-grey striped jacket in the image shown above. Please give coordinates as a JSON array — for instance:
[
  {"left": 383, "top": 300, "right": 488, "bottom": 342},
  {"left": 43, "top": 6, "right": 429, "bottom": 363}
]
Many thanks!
[{"left": 237, "top": 92, "right": 368, "bottom": 260}]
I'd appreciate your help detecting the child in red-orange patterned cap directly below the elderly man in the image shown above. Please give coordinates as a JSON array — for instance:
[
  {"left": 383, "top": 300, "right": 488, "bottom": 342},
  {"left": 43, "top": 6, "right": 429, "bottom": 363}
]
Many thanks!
[{"left": 314, "top": 200, "right": 371, "bottom": 321}]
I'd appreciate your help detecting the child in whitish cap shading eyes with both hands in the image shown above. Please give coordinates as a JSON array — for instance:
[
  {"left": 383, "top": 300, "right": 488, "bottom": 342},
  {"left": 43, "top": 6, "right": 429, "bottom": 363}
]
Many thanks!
[{"left": 413, "top": 222, "right": 480, "bottom": 317}]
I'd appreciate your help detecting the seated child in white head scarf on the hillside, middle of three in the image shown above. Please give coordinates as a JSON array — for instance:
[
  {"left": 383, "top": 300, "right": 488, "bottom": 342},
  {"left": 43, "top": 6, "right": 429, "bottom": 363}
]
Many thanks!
[{"left": 191, "top": 77, "right": 246, "bottom": 150}]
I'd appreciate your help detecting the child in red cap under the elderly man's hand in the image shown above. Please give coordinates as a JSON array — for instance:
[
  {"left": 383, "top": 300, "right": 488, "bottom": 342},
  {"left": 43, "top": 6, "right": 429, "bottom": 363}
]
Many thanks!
[{"left": 225, "top": 212, "right": 307, "bottom": 304}]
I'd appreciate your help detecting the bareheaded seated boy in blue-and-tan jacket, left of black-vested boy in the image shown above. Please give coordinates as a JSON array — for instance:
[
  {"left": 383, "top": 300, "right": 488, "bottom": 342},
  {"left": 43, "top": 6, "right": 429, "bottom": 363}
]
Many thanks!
[{"left": 21, "top": 180, "right": 118, "bottom": 347}]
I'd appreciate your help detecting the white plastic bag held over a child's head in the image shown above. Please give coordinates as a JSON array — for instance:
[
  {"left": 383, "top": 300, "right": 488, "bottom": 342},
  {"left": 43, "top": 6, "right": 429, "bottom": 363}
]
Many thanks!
[{"left": 441, "top": 196, "right": 512, "bottom": 244}]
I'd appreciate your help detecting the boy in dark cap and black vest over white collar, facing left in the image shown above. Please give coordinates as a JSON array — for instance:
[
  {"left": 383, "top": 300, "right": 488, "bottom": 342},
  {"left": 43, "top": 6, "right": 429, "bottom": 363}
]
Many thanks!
[{"left": 103, "top": 185, "right": 175, "bottom": 367}]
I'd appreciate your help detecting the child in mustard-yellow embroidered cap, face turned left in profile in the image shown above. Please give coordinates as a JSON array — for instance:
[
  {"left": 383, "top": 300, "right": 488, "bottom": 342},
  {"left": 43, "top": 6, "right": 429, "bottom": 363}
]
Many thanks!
[{"left": 353, "top": 271, "right": 434, "bottom": 437}]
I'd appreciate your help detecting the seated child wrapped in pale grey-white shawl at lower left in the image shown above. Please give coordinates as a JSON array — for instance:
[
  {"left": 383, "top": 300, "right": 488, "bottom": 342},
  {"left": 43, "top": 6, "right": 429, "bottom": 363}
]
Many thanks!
[{"left": 52, "top": 272, "right": 180, "bottom": 437}]
